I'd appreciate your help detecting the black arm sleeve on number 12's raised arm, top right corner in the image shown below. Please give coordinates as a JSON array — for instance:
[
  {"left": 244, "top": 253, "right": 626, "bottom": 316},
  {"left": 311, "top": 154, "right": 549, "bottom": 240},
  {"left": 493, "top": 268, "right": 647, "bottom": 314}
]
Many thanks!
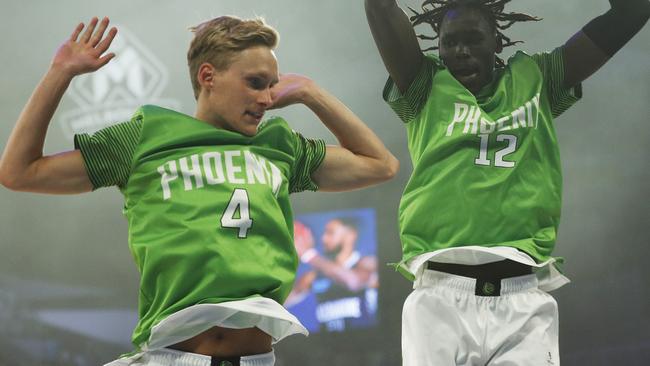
[{"left": 582, "top": 0, "right": 650, "bottom": 56}]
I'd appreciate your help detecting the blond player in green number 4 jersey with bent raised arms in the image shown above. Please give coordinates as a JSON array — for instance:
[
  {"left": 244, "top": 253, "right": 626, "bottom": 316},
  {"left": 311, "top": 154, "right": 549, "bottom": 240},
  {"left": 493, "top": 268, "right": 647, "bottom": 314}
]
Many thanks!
[{"left": 0, "top": 16, "right": 398, "bottom": 366}]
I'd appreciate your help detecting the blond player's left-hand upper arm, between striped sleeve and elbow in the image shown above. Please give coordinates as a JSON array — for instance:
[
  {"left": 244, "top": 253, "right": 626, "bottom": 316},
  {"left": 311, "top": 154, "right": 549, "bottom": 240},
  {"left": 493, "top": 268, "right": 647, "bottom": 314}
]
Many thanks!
[{"left": 3, "top": 150, "right": 93, "bottom": 194}]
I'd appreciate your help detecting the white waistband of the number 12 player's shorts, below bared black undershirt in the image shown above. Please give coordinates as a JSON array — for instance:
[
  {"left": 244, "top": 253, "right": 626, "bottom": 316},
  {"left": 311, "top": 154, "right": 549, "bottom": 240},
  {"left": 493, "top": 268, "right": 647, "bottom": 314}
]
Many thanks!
[{"left": 413, "top": 269, "right": 539, "bottom": 296}]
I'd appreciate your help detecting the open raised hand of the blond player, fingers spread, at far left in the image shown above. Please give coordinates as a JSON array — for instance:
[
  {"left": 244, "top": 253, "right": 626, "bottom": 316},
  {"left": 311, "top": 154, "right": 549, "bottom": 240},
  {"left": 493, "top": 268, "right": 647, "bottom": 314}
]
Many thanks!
[{"left": 52, "top": 17, "right": 117, "bottom": 76}]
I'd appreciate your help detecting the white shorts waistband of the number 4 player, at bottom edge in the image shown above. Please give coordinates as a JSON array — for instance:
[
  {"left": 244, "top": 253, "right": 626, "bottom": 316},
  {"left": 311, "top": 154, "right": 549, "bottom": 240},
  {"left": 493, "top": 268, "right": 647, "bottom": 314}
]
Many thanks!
[{"left": 145, "top": 348, "right": 275, "bottom": 366}]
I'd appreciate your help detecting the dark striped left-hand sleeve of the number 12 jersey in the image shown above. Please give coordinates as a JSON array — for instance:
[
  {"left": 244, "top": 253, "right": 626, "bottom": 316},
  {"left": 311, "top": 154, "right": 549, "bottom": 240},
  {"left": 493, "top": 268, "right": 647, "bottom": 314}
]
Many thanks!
[{"left": 382, "top": 56, "right": 437, "bottom": 123}]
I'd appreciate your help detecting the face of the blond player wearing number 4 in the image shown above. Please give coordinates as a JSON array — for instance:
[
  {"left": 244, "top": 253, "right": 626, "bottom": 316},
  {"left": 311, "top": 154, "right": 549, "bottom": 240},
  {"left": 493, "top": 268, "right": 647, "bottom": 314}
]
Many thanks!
[{"left": 208, "top": 46, "right": 279, "bottom": 136}]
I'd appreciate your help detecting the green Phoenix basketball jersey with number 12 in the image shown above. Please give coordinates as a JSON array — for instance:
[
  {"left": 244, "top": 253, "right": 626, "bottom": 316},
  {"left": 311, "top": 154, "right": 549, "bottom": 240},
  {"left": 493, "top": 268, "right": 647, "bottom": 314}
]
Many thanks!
[{"left": 384, "top": 49, "right": 581, "bottom": 278}]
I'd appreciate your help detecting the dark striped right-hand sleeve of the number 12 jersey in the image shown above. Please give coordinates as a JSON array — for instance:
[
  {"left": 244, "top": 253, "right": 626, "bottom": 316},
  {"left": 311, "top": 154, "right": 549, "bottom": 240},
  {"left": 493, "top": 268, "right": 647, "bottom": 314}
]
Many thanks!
[{"left": 532, "top": 47, "right": 582, "bottom": 117}]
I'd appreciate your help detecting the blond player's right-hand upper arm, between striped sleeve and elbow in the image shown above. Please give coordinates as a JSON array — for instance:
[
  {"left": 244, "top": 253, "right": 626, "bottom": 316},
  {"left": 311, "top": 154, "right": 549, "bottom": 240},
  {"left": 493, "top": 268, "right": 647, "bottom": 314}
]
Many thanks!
[{"left": 311, "top": 146, "right": 397, "bottom": 192}]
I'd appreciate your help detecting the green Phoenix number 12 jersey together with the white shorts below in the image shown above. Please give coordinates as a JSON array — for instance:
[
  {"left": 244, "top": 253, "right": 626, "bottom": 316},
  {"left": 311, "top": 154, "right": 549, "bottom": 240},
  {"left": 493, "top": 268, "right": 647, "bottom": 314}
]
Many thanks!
[{"left": 384, "top": 49, "right": 581, "bottom": 366}]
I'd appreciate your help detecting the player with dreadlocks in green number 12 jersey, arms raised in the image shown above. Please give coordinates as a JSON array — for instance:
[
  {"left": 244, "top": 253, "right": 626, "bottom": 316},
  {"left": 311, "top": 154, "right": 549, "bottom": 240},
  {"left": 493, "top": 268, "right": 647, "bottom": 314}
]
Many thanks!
[{"left": 365, "top": 0, "right": 650, "bottom": 366}]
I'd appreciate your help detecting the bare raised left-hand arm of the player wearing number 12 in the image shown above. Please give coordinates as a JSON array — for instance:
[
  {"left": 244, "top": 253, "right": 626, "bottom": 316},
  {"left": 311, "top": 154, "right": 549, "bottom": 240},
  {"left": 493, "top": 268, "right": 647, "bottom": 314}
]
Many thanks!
[{"left": 365, "top": 0, "right": 424, "bottom": 93}]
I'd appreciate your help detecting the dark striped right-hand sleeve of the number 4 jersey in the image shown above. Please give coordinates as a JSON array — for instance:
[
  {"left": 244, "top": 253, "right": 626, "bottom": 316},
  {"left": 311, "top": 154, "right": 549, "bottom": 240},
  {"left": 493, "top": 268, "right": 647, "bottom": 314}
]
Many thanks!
[{"left": 289, "top": 131, "right": 325, "bottom": 193}]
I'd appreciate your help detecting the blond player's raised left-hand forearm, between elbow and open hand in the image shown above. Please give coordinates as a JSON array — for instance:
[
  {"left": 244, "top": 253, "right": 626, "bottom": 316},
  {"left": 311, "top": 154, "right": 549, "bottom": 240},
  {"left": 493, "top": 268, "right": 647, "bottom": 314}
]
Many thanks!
[{"left": 0, "top": 68, "right": 72, "bottom": 185}]
